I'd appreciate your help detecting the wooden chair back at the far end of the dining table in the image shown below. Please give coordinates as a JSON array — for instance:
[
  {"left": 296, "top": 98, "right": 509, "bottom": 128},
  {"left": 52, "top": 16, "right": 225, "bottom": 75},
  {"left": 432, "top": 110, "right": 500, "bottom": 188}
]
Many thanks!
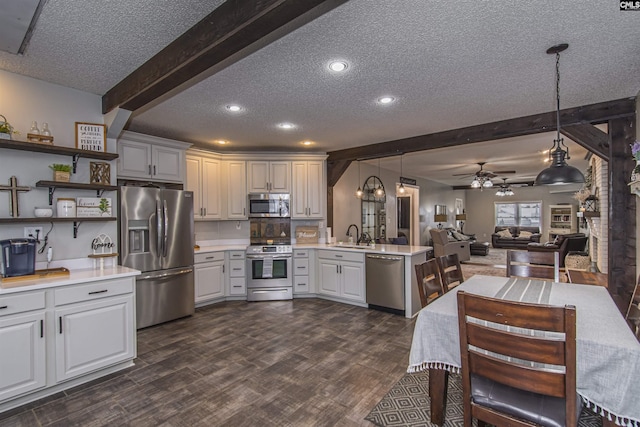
[{"left": 507, "top": 249, "right": 560, "bottom": 282}]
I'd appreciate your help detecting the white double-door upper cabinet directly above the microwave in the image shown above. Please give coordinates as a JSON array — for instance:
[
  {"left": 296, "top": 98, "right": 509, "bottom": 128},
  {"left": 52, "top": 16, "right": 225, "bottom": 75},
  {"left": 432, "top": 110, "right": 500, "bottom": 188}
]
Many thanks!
[{"left": 247, "top": 161, "right": 291, "bottom": 193}]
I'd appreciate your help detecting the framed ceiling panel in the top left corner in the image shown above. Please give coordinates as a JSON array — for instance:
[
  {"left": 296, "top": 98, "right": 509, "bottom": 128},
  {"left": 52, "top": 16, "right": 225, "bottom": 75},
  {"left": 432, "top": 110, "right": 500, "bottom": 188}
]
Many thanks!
[{"left": 0, "top": 0, "right": 46, "bottom": 55}]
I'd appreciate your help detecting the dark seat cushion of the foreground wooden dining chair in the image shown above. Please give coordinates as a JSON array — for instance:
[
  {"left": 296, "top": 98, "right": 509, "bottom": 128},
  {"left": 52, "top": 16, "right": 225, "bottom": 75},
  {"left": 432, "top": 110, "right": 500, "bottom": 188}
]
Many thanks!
[{"left": 471, "top": 374, "right": 582, "bottom": 427}]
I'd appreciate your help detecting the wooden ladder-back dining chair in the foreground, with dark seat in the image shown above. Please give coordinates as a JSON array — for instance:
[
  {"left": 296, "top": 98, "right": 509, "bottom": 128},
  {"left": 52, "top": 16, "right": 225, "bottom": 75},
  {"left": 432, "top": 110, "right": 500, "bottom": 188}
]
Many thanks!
[{"left": 457, "top": 291, "right": 582, "bottom": 427}]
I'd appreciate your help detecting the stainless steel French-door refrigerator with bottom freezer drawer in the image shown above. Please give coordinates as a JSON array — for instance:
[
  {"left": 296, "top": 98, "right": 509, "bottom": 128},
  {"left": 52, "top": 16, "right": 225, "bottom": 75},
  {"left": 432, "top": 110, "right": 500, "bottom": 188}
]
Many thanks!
[{"left": 119, "top": 186, "right": 195, "bottom": 329}]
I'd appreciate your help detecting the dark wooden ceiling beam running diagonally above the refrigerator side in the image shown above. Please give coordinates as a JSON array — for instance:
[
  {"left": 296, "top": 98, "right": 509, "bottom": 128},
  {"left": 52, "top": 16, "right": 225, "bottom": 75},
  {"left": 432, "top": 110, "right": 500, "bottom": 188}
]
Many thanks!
[{"left": 102, "top": 0, "right": 347, "bottom": 114}]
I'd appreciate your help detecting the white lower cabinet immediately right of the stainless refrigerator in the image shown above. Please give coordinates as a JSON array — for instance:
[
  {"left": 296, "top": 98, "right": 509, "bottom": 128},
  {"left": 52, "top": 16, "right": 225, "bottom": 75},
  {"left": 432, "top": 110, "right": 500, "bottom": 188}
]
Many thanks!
[{"left": 194, "top": 252, "right": 225, "bottom": 304}]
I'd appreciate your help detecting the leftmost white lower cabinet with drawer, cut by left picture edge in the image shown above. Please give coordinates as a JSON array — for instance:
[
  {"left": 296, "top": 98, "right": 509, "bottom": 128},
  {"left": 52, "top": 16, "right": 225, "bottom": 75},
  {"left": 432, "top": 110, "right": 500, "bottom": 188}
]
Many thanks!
[{"left": 0, "top": 292, "right": 46, "bottom": 402}]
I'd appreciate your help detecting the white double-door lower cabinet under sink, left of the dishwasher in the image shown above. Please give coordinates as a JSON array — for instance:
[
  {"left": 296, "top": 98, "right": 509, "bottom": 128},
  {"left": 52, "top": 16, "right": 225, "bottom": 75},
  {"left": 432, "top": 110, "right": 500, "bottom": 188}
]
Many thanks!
[{"left": 318, "top": 250, "right": 366, "bottom": 303}]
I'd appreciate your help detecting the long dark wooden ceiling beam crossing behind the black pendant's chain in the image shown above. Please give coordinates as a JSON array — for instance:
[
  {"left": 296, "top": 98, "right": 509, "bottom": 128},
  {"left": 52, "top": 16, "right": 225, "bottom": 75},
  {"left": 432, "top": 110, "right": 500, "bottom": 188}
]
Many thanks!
[{"left": 327, "top": 98, "right": 635, "bottom": 162}]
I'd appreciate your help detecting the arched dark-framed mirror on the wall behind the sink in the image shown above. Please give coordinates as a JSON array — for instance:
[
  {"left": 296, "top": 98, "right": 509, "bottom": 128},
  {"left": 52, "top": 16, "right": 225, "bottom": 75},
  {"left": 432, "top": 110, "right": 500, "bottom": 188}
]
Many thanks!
[{"left": 361, "top": 175, "right": 387, "bottom": 241}]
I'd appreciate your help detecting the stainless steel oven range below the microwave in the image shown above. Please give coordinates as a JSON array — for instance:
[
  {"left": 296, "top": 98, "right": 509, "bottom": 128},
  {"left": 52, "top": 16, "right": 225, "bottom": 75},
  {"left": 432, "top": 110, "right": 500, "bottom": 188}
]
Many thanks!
[{"left": 246, "top": 245, "right": 293, "bottom": 301}]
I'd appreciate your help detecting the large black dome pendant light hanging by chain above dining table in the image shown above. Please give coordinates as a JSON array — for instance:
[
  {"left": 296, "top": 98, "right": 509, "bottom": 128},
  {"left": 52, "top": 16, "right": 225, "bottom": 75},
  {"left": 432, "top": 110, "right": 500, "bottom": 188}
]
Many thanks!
[{"left": 535, "top": 43, "right": 584, "bottom": 185}]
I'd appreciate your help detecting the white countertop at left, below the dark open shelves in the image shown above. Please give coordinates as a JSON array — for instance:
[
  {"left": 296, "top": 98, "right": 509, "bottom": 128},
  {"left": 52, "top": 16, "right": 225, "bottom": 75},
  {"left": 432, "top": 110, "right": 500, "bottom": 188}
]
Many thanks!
[{"left": 0, "top": 265, "right": 140, "bottom": 295}]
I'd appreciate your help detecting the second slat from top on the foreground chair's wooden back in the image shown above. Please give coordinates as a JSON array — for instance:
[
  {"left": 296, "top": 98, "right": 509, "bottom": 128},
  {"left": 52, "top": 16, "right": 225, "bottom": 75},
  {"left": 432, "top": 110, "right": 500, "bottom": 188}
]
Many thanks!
[{"left": 467, "top": 323, "right": 565, "bottom": 365}]
